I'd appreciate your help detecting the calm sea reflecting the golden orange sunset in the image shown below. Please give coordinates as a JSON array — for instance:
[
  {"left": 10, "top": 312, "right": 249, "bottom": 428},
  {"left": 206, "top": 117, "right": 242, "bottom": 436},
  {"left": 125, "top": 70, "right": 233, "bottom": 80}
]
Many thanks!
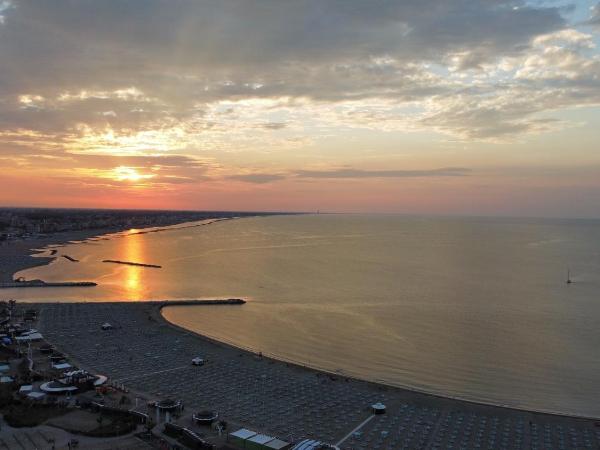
[{"left": 3, "top": 215, "right": 600, "bottom": 417}]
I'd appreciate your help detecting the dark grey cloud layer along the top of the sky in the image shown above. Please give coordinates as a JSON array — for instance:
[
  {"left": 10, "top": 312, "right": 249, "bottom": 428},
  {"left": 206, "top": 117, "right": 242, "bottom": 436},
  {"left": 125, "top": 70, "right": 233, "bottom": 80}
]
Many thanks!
[{"left": 0, "top": 0, "right": 564, "bottom": 101}]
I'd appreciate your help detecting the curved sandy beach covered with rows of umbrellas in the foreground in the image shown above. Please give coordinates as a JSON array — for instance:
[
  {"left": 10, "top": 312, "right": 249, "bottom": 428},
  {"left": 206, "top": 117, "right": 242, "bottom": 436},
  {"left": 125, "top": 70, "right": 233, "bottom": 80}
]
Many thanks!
[{"left": 36, "top": 303, "right": 600, "bottom": 450}]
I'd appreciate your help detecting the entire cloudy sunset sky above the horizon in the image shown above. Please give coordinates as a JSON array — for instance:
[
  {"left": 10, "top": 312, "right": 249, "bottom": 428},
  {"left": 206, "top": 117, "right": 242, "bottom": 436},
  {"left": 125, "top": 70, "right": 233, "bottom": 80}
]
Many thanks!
[{"left": 0, "top": 0, "right": 600, "bottom": 217}]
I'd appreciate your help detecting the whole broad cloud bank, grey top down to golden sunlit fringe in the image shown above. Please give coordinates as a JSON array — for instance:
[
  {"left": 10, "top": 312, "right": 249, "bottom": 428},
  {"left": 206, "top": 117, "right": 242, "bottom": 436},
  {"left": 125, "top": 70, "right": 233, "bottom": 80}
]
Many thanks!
[{"left": 0, "top": 0, "right": 598, "bottom": 153}]
